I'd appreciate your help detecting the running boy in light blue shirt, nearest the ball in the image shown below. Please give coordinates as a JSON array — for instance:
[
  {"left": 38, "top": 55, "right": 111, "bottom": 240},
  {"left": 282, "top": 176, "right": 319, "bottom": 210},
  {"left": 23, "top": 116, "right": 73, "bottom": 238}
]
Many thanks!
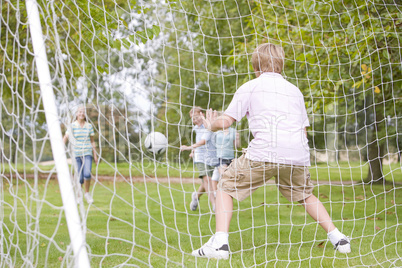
[{"left": 180, "top": 106, "right": 219, "bottom": 211}]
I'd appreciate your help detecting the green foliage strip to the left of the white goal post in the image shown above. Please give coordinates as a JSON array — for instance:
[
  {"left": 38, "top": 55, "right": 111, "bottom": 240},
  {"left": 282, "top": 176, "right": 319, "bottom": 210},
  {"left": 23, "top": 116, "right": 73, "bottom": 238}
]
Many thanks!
[{"left": 0, "top": 1, "right": 49, "bottom": 163}]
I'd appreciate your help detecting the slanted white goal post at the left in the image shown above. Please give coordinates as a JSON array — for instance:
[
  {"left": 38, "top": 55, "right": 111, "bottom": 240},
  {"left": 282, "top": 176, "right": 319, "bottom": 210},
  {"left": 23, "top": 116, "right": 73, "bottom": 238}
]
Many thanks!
[{"left": 26, "top": 0, "right": 90, "bottom": 267}]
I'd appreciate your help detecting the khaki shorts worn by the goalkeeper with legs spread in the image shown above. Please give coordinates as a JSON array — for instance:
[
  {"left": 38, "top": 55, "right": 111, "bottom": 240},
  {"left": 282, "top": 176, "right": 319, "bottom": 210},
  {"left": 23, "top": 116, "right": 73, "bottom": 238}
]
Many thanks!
[{"left": 218, "top": 154, "right": 314, "bottom": 202}]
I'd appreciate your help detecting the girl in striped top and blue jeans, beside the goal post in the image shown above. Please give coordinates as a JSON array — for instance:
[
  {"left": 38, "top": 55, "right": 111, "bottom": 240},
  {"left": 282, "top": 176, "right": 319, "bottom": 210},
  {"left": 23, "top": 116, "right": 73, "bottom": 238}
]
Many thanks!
[{"left": 63, "top": 107, "right": 98, "bottom": 204}]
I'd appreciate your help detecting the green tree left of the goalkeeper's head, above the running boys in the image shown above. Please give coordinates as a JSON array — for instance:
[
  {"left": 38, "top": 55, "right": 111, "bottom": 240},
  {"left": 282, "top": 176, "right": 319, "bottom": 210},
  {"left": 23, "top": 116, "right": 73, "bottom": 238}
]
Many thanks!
[{"left": 152, "top": 1, "right": 258, "bottom": 161}]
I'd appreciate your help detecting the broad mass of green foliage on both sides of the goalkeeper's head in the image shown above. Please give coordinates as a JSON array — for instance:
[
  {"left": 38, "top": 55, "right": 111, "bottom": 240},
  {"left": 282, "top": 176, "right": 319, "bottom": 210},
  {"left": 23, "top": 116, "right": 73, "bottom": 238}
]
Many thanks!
[{"left": 158, "top": 0, "right": 402, "bottom": 166}]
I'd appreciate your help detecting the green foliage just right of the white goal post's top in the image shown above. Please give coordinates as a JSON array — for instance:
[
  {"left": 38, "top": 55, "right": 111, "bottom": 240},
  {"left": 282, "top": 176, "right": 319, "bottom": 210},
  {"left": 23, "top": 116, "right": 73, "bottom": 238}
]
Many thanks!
[{"left": 44, "top": 0, "right": 160, "bottom": 99}]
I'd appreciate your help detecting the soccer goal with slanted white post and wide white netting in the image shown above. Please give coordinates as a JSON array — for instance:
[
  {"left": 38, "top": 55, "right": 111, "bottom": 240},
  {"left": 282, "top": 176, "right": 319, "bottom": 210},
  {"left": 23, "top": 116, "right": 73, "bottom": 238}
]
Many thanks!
[{"left": 0, "top": 0, "right": 402, "bottom": 267}]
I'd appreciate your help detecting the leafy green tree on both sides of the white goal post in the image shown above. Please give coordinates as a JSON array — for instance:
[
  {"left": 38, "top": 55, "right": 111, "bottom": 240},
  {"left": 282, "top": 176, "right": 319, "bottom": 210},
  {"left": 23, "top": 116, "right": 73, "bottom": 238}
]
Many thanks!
[{"left": 0, "top": 0, "right": 159, "bottom": 162}]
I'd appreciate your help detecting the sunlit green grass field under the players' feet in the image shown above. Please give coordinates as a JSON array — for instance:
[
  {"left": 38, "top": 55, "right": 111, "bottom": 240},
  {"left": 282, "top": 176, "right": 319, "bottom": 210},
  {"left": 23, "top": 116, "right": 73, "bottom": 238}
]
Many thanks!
[{"left": 1, "top": 164, "right": 402, "bottom": 267}]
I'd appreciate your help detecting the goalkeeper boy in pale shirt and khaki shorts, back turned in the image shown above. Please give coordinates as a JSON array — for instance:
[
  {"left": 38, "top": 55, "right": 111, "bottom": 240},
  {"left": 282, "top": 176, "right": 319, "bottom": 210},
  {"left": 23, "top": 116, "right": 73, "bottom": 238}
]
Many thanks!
[{"left": 192, "top": 44, "right": 351, "bottom": 259}]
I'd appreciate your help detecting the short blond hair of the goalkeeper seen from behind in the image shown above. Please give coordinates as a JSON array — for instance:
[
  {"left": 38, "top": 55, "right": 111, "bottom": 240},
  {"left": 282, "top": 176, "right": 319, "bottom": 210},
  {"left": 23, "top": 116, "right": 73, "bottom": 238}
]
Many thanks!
[{"left": 251, "top": 43, "right": 285, "bottom": 73}]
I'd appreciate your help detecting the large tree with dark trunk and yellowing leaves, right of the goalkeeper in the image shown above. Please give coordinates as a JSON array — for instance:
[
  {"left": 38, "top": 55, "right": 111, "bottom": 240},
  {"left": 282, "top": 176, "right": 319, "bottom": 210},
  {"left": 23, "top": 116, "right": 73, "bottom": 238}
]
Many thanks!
[{"left": 220, "top": 1, "right": 402, "bottom": 182}]
